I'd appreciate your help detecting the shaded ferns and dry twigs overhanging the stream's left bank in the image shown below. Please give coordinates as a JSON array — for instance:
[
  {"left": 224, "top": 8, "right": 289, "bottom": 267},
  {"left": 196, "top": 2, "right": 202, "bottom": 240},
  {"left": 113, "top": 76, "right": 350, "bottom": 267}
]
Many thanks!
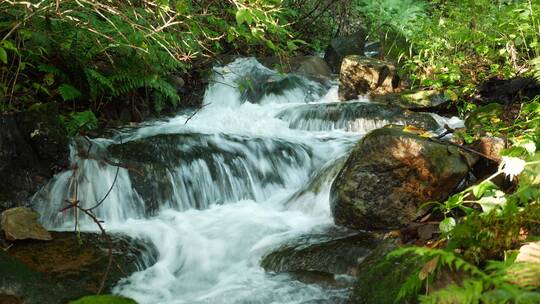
[{"left": 0, "top": 0, "right": 295, "bottom": 122}]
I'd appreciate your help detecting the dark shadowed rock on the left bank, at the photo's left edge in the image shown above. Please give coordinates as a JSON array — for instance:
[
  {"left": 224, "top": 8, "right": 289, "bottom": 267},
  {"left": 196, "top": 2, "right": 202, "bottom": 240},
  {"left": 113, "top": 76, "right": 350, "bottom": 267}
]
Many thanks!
[{"left": 0, "top": 103, "right": 68, "bottom": 212}]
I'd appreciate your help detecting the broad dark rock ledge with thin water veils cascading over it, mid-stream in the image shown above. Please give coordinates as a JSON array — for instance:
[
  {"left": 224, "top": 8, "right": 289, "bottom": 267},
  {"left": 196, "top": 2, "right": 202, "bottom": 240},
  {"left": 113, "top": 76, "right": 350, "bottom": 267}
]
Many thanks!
[{"left": 109, "top": 133, "right": 312, "bottom": 215}]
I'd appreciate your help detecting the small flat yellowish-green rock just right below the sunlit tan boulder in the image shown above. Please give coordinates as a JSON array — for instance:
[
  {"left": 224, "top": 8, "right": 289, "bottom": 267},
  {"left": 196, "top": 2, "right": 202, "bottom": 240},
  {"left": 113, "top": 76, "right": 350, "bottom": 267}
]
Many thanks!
[{"left": 371, "top": 90, "right": 448, "bottom": 111}]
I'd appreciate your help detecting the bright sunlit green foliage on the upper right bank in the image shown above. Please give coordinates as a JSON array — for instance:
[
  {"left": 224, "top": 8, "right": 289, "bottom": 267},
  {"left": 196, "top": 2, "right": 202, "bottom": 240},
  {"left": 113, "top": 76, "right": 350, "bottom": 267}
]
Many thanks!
[{"left": 400, "top": 0, "right": 540, "bottom": 112}]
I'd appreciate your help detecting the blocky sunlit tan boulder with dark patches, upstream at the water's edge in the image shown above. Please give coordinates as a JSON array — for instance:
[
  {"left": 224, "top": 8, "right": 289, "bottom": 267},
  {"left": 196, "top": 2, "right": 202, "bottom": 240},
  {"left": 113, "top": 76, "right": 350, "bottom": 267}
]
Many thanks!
[{"left": 339, "top": 55, "right": 402, "bottom": 100}]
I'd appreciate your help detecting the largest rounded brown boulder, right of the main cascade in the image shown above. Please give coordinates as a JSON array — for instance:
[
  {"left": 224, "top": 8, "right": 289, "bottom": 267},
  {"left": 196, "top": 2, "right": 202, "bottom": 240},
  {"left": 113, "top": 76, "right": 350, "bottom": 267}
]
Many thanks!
[{"left": 330, "top": 126, "right": 476, "bottom": 230}]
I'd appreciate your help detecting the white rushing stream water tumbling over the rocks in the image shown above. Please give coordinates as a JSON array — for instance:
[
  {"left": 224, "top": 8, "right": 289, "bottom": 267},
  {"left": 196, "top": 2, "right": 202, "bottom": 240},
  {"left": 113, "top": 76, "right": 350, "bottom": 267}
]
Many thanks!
[{"left": 34, "top": 59, "right": 450, "bottom": 303}]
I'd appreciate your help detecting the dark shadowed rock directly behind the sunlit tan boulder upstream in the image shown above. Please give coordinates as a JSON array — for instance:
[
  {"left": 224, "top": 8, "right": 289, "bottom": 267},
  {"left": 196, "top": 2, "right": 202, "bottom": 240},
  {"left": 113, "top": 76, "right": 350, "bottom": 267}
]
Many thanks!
[{"left": 324, "top": 30, "right": 367, "bottom": 74}]
